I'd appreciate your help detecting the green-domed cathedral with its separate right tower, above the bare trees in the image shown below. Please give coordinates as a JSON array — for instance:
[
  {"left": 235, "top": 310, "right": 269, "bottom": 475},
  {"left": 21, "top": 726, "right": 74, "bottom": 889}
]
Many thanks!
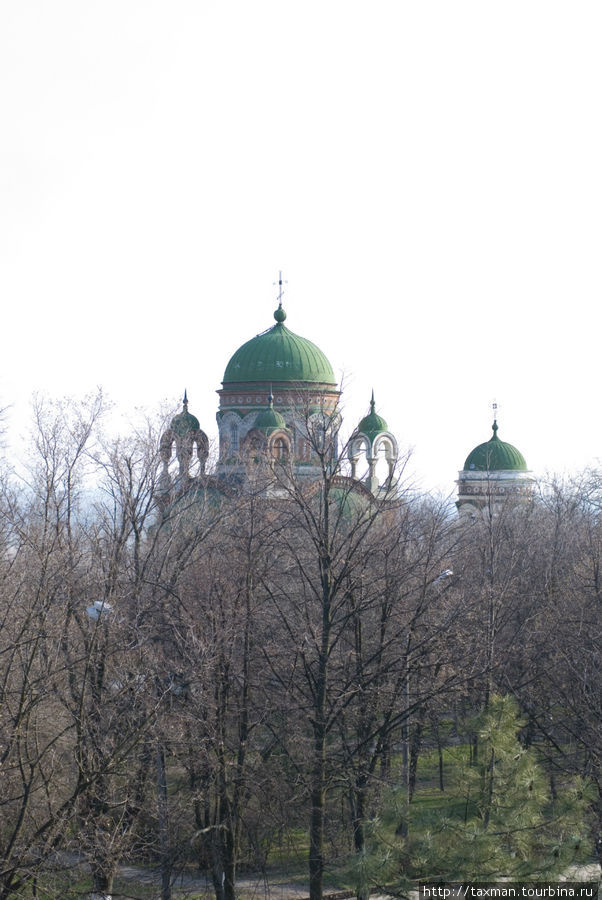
[{"left": 160, "top": 281, "right": 534, "bottom": 514}]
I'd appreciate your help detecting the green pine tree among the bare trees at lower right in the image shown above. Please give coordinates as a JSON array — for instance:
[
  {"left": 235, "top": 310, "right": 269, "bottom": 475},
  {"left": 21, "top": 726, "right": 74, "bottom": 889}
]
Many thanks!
[{"left": 356, "top": 695, "right": 591, "bottom": 895}]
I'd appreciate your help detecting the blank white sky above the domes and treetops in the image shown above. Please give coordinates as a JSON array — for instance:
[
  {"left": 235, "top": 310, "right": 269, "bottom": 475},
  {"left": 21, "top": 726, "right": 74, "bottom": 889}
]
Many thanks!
[{"left": 0, "top": 0, "right": 602, "bottom": 492}]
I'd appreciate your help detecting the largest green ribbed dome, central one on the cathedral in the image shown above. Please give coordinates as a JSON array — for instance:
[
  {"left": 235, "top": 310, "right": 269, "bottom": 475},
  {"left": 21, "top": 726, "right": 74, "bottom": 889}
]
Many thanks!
[{"left": 223, "top": 307, "right": 336, "bottom": 385}]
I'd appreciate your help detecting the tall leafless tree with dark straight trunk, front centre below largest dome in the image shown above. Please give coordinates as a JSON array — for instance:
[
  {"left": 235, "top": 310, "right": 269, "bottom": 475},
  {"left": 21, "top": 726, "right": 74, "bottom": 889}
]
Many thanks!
[{"left": 255, "top": 409, "right": 424, "bottom": 900}]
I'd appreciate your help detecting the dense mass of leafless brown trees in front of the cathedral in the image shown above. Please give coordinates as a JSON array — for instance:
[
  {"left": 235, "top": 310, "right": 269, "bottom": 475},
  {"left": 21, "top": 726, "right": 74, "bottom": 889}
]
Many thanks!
[{"left": 0, "top": 397, "right": 602, "bottom": 900}]
